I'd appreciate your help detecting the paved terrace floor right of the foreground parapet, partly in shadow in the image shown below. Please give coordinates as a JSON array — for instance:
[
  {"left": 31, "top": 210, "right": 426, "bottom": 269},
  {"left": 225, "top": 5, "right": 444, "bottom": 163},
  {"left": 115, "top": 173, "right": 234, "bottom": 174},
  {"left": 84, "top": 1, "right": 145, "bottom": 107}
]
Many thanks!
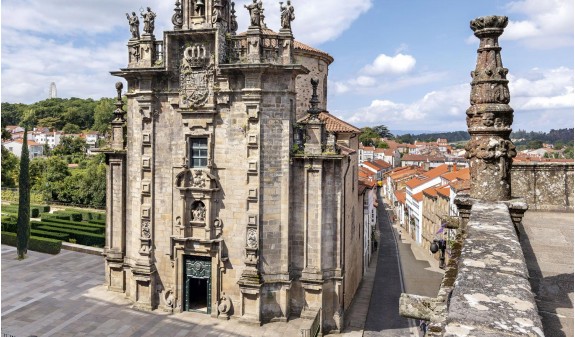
[{"left": 520, "top": 211, "right": 574, "bottom": 337}]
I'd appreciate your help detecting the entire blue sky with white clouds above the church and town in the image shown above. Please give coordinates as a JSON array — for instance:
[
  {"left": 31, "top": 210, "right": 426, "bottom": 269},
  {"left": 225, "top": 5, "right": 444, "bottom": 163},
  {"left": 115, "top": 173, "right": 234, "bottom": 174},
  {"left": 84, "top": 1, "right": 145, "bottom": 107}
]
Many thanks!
[{"left": 1, "top": 0, "right": 574, "bottom": 131}]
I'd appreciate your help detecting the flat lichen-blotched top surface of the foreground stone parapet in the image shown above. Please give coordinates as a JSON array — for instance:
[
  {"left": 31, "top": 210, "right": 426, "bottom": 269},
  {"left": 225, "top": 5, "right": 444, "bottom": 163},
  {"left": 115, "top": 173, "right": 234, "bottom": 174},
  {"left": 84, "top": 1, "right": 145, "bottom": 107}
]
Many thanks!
[{"left": 445, "top": 202, "right": 543, "bottom": 336}]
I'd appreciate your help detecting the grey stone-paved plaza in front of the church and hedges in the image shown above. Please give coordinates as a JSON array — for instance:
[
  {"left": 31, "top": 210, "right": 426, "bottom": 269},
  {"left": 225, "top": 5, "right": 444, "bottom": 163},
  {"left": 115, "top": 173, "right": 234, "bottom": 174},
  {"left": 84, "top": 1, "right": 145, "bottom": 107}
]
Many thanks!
[{"left": 1, "top": 245, "right": 310, "bottom": 337}]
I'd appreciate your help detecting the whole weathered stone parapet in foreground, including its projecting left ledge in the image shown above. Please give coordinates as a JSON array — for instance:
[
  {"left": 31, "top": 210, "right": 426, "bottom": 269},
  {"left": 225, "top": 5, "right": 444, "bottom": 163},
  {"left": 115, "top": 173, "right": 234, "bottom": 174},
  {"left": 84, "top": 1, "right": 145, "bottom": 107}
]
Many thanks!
[{"left": 400, "top": 201, "right": 543, "bottom": 337}]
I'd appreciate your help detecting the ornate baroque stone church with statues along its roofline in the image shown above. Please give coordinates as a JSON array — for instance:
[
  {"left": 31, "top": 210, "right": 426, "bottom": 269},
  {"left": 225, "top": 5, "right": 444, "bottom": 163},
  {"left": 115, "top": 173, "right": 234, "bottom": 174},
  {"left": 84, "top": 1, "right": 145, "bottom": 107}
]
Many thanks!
[{"left": 104, "top": 0, "right": 363, "bottom": 332}]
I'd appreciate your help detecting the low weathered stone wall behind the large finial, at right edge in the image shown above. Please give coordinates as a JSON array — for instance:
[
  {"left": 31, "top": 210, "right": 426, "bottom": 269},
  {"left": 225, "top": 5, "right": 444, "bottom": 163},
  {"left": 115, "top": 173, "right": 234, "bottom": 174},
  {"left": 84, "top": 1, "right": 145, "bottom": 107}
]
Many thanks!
[{"left": 511, "top": 162, "right": 573, "bottom": 211}]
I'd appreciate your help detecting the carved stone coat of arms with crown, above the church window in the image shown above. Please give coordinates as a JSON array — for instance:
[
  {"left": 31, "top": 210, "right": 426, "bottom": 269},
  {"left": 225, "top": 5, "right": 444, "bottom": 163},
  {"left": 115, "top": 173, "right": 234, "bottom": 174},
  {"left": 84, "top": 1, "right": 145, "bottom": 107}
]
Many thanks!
[{"left": 180, "top": 44, "right": 213, "bottom": 109}]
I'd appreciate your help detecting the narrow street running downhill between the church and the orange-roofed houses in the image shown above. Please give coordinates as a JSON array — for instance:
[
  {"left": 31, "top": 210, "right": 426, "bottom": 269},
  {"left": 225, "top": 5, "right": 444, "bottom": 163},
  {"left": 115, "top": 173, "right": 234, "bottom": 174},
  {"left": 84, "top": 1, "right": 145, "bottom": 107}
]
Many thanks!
[{"left": 363, "top": 190, "right": 443, "bottom": 337}]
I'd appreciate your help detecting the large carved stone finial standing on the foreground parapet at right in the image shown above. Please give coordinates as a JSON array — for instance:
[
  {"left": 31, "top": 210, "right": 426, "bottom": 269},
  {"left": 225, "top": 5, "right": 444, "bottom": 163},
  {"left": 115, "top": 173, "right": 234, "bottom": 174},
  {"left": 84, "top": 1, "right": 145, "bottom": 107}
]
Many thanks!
[{"left": 466, "top": 16, "right": 516, "bottom": 201}]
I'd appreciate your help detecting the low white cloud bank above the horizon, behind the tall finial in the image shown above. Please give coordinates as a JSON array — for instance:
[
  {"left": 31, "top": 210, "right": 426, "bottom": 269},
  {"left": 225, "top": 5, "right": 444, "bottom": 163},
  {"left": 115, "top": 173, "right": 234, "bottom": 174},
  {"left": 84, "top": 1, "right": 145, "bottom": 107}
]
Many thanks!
[{"left": 338, "top": 67, "right": 575, "bottom": 131}]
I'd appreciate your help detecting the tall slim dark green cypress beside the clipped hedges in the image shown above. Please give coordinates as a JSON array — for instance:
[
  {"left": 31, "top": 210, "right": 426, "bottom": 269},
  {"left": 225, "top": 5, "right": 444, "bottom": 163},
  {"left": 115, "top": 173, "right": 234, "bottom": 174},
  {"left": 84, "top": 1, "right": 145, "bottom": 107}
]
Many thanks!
[{"left": 16, "top": 128, "right": 30, "bottom": 260}]
